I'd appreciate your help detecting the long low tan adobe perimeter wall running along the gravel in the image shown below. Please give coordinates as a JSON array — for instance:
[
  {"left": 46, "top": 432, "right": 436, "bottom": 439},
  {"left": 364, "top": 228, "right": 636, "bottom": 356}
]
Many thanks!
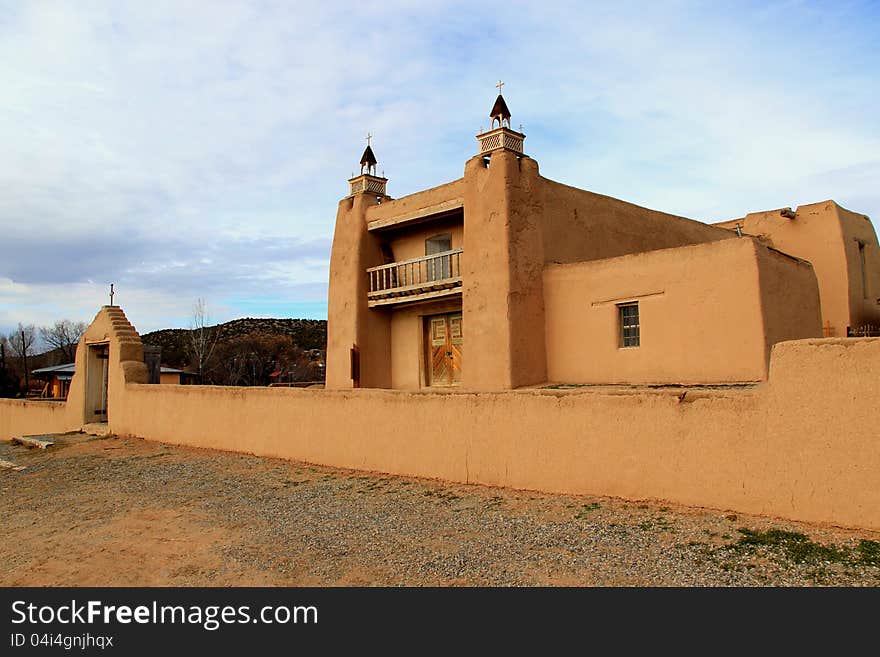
[{"left": 0, "top": 310, "right": 880, "bottom": 529}]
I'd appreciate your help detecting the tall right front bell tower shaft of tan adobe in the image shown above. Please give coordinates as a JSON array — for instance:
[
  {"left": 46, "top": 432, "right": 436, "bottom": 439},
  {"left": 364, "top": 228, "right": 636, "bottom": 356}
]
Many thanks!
[{"left": 461, "top": 150, "right": 547, "bottom": 390}]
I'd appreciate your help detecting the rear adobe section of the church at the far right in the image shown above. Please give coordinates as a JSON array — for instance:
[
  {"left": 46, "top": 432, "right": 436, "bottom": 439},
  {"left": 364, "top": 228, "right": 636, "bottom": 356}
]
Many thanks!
[{"left": 715, "top": 201, "right": 880, "bottom": 337}]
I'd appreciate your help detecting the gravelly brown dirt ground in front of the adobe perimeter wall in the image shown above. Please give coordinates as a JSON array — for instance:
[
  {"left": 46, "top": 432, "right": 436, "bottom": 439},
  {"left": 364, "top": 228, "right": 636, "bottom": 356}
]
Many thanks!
[{"left": 0, "top": 434, "right": 880, "bottom": 586}]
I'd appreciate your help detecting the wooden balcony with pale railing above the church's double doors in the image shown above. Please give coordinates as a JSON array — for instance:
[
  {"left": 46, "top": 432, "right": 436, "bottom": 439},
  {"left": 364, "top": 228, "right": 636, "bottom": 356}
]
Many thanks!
[{"left": 367, "top": 249, "right": 462, "bottom": 307}]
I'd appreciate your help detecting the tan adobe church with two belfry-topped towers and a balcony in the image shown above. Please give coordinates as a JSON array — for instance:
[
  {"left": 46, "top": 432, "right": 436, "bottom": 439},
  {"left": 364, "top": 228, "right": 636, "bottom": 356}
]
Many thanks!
[{"left": 327, "top": 84, "right": 880, "bottom": 390}]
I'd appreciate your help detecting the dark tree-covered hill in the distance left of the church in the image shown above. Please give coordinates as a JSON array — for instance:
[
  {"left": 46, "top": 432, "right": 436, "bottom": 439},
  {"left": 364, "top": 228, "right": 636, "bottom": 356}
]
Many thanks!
[{"left": 141, "top": 317, "right": 327, "bottom": 367}]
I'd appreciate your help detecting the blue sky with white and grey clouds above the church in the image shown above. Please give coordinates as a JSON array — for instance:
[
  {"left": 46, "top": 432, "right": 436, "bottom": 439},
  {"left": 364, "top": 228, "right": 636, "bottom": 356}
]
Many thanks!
[{"left": 0, "top": 0, "right": 880, "bottom": 332}]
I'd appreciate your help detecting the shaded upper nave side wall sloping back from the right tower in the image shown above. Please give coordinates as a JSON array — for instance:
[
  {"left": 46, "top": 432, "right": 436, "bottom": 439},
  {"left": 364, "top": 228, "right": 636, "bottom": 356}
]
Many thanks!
[{"left": 541, "top": 178, "right": 729, "bottom": 263}]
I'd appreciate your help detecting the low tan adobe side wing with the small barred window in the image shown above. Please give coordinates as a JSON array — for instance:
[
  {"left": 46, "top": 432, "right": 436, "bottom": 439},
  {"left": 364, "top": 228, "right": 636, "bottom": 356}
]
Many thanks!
[{"left": 544, "top": 237, "right": 821, "bottom": 383}]
